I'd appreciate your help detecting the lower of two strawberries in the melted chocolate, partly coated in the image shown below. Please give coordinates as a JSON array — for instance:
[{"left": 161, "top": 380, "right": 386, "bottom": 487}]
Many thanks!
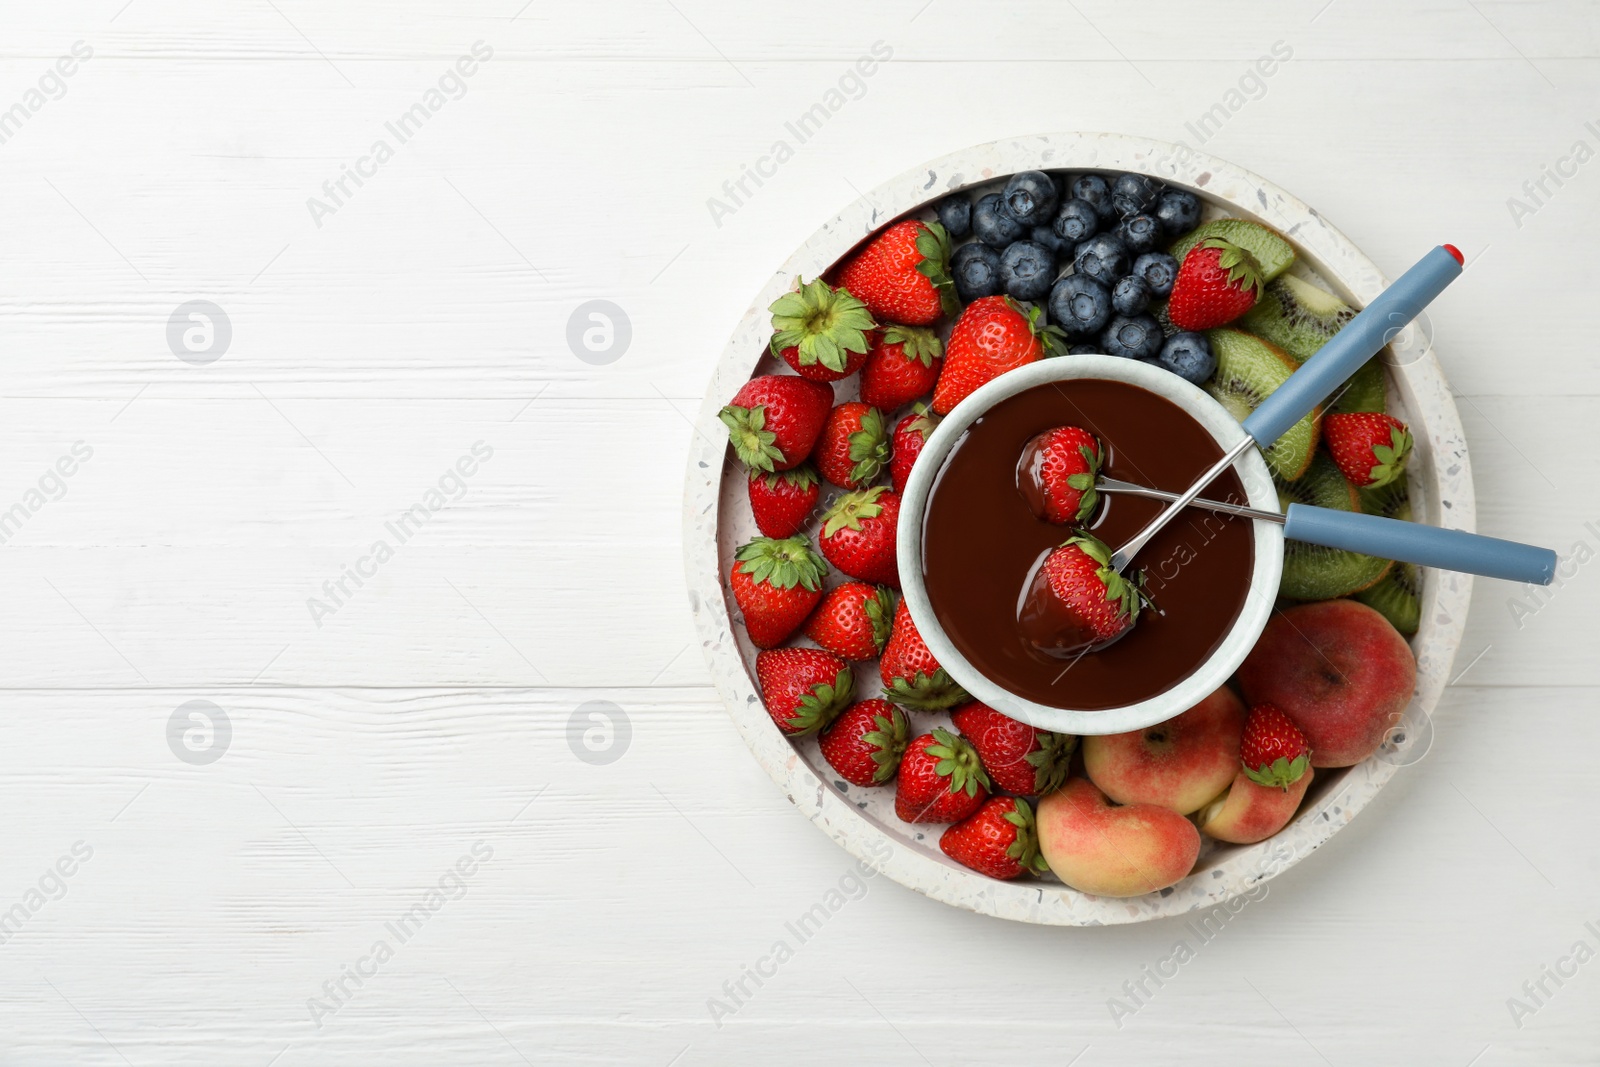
[{"left": 1018, "top": 534, "right": 1146, "bottom": 656}]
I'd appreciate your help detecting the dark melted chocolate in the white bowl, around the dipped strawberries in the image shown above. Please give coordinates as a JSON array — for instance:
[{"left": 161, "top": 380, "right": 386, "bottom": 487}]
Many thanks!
[{"left": 922, "top": 375, "right": 1254, "bottom": 710}]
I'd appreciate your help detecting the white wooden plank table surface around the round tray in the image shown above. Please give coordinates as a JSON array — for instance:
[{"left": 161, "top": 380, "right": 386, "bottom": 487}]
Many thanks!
[{"left": 0, "top": 0, "right": 1600, "bottom": 1067}]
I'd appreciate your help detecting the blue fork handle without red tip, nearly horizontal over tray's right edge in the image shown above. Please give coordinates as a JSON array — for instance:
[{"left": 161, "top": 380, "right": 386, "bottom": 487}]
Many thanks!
[{"left": 1283, "top": 504, "right": 1555, "bottom": 585}]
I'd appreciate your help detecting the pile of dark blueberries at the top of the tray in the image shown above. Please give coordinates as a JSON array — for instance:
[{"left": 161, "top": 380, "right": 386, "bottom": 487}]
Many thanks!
[{"left": 934, "top": 171, "right": 1216, "bottom": 386}]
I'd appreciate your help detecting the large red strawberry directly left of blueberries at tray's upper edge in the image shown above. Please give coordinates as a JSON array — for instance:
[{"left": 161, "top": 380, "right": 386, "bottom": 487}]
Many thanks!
[{"left": 837, "top": 219, "right": 957, "bottom": 326}]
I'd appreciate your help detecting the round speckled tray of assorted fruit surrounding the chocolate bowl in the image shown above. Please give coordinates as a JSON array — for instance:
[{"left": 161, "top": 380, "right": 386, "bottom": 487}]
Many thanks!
[{"left": 685, "top": 133, "right": 1474, "bottom": 926}]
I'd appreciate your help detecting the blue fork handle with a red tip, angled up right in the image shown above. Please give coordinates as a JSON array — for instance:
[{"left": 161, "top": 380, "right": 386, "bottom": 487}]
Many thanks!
[{"left": 1245, "top": 245, "right": 1461, "bottom": 448}]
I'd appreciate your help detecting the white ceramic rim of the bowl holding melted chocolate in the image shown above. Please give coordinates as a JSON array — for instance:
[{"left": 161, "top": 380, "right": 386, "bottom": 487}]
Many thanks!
[{"left": 896, "top": 355, "right": 1283, "bottom": 734}]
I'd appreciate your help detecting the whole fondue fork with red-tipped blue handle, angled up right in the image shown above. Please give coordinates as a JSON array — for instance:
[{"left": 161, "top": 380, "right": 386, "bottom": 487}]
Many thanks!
[{"left": 1110, "top": 245, "right": 1462, "bottom": 573}]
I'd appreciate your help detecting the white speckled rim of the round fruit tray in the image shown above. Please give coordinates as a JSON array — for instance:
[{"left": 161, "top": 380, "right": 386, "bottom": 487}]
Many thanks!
[{"left": 683, "top": 133, "right": 1475, "bottom": 926}]
